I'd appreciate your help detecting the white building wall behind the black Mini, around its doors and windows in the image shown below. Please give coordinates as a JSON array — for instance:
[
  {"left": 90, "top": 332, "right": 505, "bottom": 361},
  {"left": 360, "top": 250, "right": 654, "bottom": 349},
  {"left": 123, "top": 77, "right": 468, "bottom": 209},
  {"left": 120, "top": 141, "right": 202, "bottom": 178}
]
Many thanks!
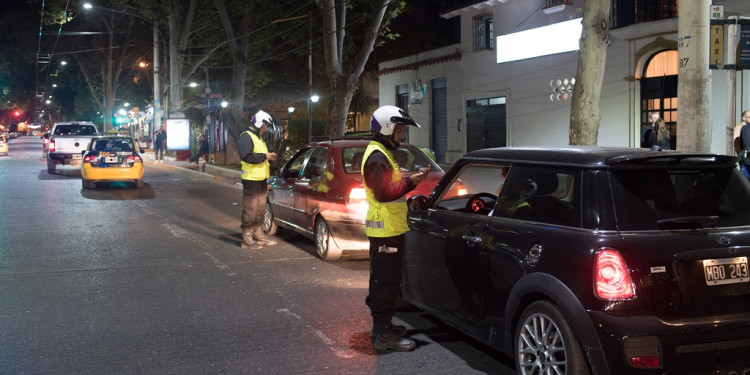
[{"left": 379, "top": 0, "right": 750, "bottom": 163}]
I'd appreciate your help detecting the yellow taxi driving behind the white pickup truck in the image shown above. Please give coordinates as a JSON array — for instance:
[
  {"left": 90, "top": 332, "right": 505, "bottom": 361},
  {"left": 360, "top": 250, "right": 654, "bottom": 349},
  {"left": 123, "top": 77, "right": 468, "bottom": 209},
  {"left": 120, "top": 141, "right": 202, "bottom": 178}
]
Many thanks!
[{"left": 81, "top": 135, "right": 143, "bottom": 189}]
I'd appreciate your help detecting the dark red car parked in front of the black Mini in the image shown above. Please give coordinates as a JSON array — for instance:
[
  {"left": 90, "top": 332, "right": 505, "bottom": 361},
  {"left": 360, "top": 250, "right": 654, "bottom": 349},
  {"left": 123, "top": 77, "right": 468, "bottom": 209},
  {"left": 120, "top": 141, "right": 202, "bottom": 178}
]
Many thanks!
[{"left": 264, "top": 137, "right": 452, "bottom": 261}]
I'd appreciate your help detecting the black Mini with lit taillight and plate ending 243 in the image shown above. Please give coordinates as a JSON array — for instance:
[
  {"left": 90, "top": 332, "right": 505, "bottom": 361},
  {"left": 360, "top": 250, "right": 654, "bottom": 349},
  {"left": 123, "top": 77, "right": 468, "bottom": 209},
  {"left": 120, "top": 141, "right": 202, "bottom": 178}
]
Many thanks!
[{"left": 402, "top": 147, "right": 750, "bottom": 374}]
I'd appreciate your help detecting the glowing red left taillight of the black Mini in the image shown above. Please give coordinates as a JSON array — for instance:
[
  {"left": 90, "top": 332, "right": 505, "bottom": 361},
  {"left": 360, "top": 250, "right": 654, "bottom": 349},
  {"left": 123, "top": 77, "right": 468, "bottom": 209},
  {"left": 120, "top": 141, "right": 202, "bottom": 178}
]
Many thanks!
[{"left": 594, "top": 249, "right": 635, "bottom": 300}]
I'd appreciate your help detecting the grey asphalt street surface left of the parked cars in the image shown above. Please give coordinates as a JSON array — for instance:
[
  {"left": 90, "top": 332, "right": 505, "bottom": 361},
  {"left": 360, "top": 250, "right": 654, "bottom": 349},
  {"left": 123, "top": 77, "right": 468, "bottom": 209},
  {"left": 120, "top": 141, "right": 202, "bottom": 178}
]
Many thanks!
[{"left": 0, "top": 136, "right": 515, "bottom": 374}]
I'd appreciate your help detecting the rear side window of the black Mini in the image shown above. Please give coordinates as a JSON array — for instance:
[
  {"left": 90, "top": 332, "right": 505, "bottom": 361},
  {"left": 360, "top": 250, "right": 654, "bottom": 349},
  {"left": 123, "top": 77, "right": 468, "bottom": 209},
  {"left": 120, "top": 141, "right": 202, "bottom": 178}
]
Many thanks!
[{"left": 493, "top": 165, "right": 580, "bottom": 226}]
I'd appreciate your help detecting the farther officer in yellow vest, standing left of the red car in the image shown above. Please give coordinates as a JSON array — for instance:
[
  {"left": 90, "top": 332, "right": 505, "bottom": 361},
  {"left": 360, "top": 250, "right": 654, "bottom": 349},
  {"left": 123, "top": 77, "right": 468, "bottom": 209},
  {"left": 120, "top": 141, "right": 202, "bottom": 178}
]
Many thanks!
[{"left": 237, "top": 111, "right": 276, "bottom": 250}]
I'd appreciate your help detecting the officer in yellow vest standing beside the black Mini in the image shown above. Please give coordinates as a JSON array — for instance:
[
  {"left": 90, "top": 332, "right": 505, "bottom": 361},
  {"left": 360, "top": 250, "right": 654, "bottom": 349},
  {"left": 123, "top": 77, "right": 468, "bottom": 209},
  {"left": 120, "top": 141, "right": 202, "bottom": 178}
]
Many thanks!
[{"left": 361, "top": 106, "right": 428, "bottom": 351}]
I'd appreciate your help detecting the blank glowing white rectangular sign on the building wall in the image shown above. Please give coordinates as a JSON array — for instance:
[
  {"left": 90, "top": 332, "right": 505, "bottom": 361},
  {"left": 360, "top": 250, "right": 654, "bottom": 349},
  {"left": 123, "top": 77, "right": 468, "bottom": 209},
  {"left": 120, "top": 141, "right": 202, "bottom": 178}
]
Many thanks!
[{"left": 496, "top": 18, "right": 583, "bottom": 64}]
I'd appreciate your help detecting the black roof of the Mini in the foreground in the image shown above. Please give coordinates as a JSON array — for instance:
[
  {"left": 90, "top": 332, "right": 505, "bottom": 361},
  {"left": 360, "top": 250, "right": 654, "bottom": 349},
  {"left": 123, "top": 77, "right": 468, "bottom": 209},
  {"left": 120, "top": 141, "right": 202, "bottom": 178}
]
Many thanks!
[{"left": 461, "top": 146, "right": 739, "bottom": 168}]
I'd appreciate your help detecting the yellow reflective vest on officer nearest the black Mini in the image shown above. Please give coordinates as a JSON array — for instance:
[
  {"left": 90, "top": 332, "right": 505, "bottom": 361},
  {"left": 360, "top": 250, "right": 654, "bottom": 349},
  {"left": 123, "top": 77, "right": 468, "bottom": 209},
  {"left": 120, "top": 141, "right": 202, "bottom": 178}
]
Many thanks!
[{"left": 361, "top": 141, "right": 409, "bottom": 237}]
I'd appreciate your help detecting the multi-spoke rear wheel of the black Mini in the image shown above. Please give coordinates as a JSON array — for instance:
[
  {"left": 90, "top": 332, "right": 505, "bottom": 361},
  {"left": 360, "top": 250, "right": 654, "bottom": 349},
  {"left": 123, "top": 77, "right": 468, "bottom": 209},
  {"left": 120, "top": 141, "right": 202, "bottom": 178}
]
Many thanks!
[{"left": 514, "top": 301, "right": 591, "bottom": 375}]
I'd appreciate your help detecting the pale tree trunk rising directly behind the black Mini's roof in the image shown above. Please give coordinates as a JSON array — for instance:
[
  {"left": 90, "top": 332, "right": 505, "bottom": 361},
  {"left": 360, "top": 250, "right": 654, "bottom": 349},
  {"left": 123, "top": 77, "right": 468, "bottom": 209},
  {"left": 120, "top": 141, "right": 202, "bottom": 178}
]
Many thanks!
[{"left": 569, "top": 0, "right": 610, "bottom": 146}]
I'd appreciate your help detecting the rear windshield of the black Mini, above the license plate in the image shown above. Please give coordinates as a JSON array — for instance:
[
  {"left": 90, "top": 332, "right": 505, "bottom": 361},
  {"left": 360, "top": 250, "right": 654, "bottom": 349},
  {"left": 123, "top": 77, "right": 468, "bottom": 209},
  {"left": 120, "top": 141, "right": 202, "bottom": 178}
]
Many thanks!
[{"left": 610, "top": 167, "right": 750, "bottom": 230}]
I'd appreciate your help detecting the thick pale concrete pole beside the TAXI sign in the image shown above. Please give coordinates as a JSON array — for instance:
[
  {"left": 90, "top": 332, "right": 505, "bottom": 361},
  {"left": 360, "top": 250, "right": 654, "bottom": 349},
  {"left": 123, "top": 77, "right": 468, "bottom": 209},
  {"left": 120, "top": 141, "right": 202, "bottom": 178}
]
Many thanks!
[{"left": 677, "top": 0, "right": 712, "bottom": 152}]
